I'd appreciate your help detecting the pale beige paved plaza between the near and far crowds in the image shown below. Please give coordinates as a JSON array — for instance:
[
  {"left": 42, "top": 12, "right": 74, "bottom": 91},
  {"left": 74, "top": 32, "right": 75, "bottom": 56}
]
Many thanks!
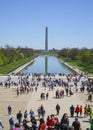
[{"left": 0, "top": 76, "right": 92, "bottom": 130}]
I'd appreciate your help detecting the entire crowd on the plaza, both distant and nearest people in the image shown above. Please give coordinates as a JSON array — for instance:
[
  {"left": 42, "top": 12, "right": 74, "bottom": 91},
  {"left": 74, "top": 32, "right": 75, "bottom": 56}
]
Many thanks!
[{"left": 0, "top": 74, "right": 93, "bottom": 130}]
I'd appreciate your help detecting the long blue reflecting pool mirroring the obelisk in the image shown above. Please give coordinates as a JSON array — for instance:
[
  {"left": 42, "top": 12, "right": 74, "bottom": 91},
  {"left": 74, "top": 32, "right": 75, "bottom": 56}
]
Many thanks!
[{"left": 20, "top": 56, "right": 74, "bottom": 74}]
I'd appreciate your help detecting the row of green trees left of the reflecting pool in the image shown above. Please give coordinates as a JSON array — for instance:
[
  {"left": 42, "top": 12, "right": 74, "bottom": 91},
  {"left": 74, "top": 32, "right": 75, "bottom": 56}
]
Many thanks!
[{"left": 0, "top": 46, "right": 34, "bottom": 66}]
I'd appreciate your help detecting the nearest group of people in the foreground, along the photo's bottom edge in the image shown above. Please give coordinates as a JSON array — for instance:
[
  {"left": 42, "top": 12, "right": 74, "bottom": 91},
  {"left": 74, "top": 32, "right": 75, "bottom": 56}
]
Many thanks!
[{"left": 4, "top": 104, "right": 93, "bottom": 130}]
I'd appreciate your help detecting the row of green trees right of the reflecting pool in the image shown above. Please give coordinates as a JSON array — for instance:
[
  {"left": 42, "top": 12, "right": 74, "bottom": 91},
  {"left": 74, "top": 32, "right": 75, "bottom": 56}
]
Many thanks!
[{"left": 58, "top": 48, "right": 93, "bottom": 65}]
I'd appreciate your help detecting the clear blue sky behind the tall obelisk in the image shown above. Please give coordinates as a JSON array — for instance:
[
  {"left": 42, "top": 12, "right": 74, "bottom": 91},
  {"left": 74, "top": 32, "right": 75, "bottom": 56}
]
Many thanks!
[{"left": 0, "top": 0, "right": 93, "bottom": 49}]
